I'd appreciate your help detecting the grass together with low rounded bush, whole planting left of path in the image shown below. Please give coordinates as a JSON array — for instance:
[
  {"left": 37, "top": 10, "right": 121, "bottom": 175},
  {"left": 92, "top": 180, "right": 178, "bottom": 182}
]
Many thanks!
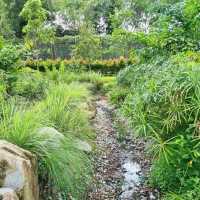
[{"left": 0, "top": 65, "right": 100, "bottom": 199}]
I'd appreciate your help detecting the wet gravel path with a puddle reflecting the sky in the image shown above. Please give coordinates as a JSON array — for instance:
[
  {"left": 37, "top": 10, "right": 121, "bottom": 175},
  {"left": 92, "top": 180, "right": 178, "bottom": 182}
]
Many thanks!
[{"left": 88, "top": 97, "right": 159, "bottom": 200}]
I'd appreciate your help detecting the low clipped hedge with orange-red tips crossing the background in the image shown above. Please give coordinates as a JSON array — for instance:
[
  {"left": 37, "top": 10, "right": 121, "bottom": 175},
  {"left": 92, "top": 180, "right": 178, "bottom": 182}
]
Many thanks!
[{"left": 24, "top": 57, "right": 134, "bottom": 74}]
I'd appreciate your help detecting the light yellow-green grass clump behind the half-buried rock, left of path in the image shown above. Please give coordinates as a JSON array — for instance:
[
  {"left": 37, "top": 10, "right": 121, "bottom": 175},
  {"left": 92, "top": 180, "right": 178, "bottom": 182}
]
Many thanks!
[{"left": 38, "top": 82, "right": 93, "bottom": 138}]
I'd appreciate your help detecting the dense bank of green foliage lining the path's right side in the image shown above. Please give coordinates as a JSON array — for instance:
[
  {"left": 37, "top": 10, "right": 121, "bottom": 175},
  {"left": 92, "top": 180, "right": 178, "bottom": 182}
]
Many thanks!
[{"left": 110, "top": 0, "right": 200, "bottom": 200}]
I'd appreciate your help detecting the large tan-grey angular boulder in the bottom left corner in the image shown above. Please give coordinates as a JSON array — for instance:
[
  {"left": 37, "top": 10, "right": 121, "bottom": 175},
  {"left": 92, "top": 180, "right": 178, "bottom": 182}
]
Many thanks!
[{"left": 0, "top": 140, "right": 39, "bottom": 200}]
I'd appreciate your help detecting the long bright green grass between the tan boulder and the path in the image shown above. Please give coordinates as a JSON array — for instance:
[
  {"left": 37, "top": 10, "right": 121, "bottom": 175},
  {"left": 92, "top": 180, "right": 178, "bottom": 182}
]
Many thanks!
[{"left": 0, "top": 83, "right": 93, "bottom": 199}]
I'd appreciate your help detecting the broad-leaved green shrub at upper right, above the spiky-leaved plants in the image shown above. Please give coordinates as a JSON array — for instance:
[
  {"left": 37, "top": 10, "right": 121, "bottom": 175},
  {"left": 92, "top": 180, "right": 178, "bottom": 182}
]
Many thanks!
[{"left": 127, "top": 0, "right": 200, "bottom": 62}]
